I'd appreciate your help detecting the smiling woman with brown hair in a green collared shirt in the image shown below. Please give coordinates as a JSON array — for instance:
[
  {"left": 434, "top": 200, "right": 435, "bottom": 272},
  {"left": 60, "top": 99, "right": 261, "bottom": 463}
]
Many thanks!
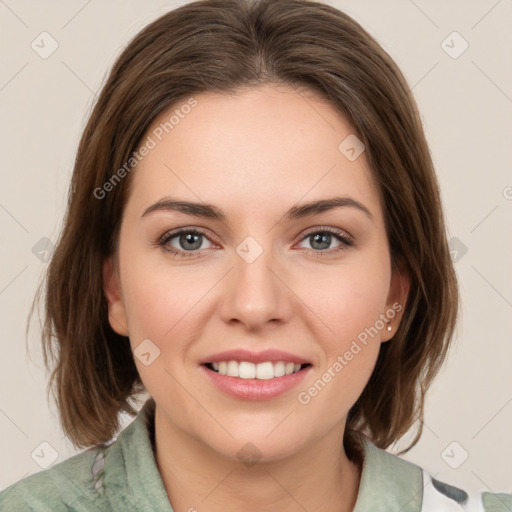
[{"left": 0, "top": 0, "right": 512, "bottom": 512}]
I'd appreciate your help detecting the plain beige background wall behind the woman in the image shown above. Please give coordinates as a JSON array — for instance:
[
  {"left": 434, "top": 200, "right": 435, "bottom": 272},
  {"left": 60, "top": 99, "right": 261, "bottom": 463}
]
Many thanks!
[{"left": 0, "top": 0, "right": 512, "bottom": 498}]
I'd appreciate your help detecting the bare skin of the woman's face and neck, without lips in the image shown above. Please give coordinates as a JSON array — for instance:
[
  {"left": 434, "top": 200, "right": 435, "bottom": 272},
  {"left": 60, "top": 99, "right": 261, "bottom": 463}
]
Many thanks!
[{"left": 103, "top": 85, "right": 409, "bottom": 512}]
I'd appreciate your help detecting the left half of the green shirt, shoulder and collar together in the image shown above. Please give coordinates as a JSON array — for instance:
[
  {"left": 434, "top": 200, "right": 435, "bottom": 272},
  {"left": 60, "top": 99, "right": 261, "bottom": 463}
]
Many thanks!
[{"left": 0, "top": 401, "right": 162, "bottom": 512}]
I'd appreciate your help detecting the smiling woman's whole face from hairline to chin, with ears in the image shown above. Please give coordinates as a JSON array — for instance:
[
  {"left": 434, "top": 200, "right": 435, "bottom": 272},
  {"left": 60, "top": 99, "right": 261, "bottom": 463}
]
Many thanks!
[{"left": 104, "top": 85, "right": 407, "bottom": 460}]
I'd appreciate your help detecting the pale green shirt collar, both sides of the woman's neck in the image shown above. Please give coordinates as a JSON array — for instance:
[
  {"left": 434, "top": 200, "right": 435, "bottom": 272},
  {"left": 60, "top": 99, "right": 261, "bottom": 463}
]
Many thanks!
[{"left": 104, "top": 398, "right": 423, "bottom": 512}]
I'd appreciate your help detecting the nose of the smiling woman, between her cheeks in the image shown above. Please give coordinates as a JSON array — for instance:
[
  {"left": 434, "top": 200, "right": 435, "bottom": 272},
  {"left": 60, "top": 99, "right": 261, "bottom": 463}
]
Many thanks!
[{"left": 220, "top": 239, "right": 293, "bottom": 331}]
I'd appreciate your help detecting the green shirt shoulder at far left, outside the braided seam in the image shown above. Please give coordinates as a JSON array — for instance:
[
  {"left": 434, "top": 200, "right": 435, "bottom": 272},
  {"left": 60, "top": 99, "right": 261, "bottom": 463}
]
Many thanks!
[{"left": 0, "top": 447, "right": 105, "bottom": 512}]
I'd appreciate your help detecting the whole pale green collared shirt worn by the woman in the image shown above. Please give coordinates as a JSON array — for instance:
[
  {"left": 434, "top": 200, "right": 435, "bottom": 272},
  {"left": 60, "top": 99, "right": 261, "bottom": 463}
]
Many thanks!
[{"left": 0, "top": 399, "right": 512, "bottom": 512}]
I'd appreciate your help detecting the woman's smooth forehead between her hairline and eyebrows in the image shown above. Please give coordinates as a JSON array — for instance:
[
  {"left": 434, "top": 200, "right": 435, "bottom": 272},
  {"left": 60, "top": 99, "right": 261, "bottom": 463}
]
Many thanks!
[{"left": 126, "top": 85, "right": 379, "bottom": 221}]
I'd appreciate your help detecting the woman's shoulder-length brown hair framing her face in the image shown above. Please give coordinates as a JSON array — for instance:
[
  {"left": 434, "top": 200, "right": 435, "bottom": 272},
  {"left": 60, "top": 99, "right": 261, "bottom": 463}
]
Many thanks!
[{"left": 29, "top": 0, "right": 458, "bottom": 457}]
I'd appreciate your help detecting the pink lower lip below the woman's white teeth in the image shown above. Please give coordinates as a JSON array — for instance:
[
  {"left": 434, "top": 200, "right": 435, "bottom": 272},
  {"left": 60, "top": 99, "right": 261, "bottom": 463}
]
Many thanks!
[{"left": 200, "top": 365, "right": 311, "bottom": 400}]
